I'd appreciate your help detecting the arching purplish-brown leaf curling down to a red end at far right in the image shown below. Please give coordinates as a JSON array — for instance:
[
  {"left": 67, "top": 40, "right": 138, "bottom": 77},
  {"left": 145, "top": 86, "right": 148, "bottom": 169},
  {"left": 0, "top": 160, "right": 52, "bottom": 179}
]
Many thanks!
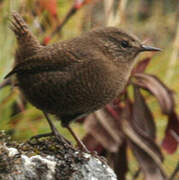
[{"left": 135, "top": 73, "right": 179, "bottom": 153}]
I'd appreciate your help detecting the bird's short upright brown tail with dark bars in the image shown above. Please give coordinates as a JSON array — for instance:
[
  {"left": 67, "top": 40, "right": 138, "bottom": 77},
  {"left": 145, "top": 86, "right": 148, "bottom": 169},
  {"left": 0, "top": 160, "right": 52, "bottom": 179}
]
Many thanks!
[{"left": 10, "top": 12, "right": 42, "bottom": 63}]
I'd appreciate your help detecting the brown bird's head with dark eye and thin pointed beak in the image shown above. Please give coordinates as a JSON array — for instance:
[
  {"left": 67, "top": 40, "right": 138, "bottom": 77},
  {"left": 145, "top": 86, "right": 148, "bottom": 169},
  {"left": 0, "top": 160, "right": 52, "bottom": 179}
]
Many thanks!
[{"left": 93, "top": 27, "right": 160, "bottom": 64}]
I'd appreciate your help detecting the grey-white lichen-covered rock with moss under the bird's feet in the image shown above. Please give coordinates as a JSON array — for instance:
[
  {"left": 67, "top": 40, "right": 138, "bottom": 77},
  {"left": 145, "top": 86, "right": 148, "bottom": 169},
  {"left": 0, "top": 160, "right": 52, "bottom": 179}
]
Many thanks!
[{"left": 0, "top": 131, "right": 117, "bottom": 180}]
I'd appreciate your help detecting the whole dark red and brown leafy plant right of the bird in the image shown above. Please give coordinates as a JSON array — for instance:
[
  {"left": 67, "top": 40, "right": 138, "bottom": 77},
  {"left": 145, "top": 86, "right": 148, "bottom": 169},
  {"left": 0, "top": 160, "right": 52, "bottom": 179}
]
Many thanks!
[{"left": 84, "top": 57, "right": 179, "bottom": 179}]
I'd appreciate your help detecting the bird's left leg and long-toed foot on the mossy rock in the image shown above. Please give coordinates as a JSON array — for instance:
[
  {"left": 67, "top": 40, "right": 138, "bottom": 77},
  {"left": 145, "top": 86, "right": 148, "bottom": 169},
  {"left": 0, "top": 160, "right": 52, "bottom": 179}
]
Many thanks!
[{"left": 30, "top": 112, "right": 71, "bottom": 144}]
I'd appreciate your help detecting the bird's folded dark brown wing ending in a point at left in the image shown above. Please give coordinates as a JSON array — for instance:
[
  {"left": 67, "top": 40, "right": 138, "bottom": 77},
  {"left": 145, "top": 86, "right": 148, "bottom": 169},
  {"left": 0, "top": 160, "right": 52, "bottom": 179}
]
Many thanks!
[{"left": 5, "top": 53, "right": 77, "bottom": 78}]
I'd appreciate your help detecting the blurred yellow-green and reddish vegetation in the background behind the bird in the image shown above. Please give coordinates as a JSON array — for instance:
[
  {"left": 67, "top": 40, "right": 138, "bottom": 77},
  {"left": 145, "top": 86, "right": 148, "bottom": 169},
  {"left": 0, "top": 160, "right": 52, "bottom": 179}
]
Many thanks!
[{"left": 0, "top": 0, "right": 179, "bottom": 179}]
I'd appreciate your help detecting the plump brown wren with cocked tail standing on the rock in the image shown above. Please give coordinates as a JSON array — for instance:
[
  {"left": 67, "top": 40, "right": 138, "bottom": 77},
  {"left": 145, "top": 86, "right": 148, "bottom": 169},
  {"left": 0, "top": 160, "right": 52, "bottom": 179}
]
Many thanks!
[{"left": 5, "top": 12, "right": 160, "bottom": 152}]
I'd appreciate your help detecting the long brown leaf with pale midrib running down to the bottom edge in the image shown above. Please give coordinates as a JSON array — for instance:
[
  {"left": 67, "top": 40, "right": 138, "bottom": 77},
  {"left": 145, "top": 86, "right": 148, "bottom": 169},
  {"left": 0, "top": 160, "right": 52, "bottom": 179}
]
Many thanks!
[{"left": 121, "top": 102, "right": 166, "bottom": 180}]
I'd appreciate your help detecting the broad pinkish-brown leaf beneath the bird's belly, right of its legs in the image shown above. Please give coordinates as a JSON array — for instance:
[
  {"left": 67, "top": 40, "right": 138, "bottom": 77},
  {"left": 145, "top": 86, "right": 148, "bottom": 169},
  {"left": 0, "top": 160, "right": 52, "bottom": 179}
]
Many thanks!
[{"left": 84, "top": 108, "right": 122, "bottom": 152}]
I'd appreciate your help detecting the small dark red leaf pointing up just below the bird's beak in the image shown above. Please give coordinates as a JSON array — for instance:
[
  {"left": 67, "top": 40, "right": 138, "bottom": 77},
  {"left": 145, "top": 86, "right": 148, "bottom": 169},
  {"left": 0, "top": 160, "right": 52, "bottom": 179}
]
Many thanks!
[{"left": 131, "top": 57, "right": 151, "bottom": 75}]
